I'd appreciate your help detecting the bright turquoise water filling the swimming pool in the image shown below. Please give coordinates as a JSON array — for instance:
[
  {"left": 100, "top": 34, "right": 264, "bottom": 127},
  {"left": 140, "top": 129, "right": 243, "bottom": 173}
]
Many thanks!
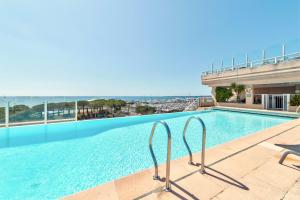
[{"left": 0, "top": 110, "right": 292, "bottom": 199}]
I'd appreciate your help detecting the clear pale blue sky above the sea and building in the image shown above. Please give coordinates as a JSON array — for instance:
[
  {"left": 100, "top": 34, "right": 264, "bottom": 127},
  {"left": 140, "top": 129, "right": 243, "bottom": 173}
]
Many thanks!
[{"left": 0, "top": 0, "right": 300, "bottom": 96}]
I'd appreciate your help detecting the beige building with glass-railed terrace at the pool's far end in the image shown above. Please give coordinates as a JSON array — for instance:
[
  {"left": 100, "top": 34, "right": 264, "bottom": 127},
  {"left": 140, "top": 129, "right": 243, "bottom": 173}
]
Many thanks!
[{"left": 201, "top": 45, "right": 300, "bottom": 111}]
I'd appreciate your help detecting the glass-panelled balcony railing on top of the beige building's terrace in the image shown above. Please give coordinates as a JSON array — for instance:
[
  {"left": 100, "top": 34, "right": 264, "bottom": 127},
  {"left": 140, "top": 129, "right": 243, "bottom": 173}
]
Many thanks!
[{"left": 202, "top": 40, "right": 300, "bottom": 76}]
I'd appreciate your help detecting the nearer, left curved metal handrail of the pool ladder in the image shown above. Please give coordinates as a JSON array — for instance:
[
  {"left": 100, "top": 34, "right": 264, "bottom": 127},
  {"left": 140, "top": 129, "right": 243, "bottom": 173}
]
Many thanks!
[{"left": 149, "top": 121, "right": 172, "bottom": 191}]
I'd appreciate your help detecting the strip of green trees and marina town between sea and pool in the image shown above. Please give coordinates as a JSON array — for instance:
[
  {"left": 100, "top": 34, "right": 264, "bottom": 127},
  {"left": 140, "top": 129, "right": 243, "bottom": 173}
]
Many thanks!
[{"left": 0, "top": 97, "right": 214, "bottom": 126}]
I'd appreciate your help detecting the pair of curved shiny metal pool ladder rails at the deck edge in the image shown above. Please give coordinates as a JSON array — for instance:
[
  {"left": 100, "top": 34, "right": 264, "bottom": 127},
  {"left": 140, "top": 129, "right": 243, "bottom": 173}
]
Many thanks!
[{"left": 149, "top": 116, "right": 206, "bottom": 192}]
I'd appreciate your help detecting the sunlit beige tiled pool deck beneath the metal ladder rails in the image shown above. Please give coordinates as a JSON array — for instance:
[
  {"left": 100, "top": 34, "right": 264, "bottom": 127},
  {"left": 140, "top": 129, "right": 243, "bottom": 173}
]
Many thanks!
[{"left": 65, "top": 116, "right": 300, "bottom": 200}]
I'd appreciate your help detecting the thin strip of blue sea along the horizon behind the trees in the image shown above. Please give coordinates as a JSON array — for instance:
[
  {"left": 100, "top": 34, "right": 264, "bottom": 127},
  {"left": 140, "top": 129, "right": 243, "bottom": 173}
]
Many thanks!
[{"left": 0, "top": 96, "right": 208, "bottom": 106}]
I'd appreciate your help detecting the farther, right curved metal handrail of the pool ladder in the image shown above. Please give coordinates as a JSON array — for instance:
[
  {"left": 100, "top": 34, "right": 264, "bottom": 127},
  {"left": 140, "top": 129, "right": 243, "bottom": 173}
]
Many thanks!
[{"left": 183, "top": 116, "right": 206, "bottom": 174}]
